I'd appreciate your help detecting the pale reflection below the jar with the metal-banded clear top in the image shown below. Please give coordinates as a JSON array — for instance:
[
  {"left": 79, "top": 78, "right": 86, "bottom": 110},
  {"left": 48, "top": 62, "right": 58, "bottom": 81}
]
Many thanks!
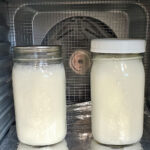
[{"left": 17, "top": 140, "right": 68, "bottom": 150}]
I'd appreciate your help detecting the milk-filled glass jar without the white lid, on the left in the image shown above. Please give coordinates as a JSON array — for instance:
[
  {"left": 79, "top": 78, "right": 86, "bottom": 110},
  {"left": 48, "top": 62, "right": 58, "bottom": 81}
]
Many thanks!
[{"left": 12, "top": 46, "right": 66, "bottom": 146}]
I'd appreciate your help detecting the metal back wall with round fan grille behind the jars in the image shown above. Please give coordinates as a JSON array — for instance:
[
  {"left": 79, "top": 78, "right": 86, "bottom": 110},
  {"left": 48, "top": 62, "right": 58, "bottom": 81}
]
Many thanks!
[{"left": 8, "top": 0, "right": 150, "bottom": 104}]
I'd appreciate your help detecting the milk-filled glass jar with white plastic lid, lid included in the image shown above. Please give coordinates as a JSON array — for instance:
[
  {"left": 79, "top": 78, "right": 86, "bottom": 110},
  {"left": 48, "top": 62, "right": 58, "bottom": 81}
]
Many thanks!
[{"left": 91, "top": 39, "right": 146, "bottom": 145}]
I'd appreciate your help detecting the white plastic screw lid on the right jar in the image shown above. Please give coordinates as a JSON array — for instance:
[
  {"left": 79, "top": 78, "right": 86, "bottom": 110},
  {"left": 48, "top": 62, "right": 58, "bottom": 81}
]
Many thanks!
[{"left": 91, "top": 39, "right": 146, "bottom": 54}]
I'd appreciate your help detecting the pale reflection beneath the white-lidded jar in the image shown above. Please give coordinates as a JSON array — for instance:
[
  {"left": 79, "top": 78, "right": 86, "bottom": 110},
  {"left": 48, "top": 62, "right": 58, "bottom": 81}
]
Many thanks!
[{"left": 91, "top": 140, "right": 144, "bottom": 150}]
